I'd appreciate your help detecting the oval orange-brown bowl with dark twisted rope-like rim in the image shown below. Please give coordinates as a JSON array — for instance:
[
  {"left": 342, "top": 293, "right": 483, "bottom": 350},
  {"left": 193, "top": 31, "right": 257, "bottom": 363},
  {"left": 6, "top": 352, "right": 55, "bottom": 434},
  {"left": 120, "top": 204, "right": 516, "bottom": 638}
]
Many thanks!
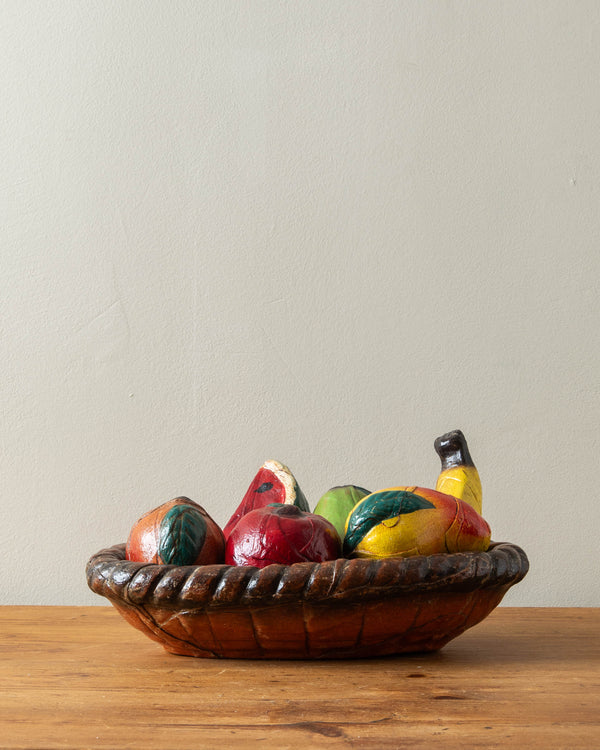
[{"left": 87, "top": 543, "right": 529, "bottom": 659}]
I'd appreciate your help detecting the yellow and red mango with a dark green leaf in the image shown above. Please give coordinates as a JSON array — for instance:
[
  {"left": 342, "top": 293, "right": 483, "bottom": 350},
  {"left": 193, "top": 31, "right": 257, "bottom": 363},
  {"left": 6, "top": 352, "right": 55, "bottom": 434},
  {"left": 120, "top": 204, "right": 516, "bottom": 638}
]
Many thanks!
[{"left": 344, "top": 487, "right": 491, "bottom": 558}]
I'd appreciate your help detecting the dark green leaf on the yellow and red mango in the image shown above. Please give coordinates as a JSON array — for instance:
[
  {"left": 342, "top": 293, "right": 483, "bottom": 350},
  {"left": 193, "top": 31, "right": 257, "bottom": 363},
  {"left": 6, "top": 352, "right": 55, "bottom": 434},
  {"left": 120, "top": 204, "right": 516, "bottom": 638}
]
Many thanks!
[{"left": 344, "top": 490, "right": 435, "bottom": 553}]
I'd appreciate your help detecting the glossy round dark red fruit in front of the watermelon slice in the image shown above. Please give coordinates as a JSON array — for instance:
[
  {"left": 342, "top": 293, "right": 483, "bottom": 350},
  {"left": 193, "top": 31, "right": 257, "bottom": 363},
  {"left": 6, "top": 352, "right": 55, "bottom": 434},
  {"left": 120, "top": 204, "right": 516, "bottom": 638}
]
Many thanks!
[{"left": 225, "top": 503, "right": 342, "bottom": 568}]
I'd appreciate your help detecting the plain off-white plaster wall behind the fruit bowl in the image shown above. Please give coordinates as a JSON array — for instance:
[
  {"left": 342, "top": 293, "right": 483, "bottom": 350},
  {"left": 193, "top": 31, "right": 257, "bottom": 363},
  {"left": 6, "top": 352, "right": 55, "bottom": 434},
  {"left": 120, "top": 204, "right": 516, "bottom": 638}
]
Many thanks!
[{"left": 0, "top": 0, "right": 600, "bottom": 605}]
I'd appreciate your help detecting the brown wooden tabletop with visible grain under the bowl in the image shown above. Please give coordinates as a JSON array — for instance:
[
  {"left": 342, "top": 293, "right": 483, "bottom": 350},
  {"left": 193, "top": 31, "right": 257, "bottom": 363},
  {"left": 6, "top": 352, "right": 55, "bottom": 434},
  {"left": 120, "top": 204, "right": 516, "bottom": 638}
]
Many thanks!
[{"left": 0, "top": 607, "right": 600, "bottom": 750}]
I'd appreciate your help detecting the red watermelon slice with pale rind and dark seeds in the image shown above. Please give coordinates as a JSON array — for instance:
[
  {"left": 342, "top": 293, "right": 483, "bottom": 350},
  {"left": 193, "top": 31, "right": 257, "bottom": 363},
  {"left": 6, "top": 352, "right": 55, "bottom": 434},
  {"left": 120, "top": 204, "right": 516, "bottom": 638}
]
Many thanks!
[{"left": 223, "top": 460, "right": 310, "bottom": 539}]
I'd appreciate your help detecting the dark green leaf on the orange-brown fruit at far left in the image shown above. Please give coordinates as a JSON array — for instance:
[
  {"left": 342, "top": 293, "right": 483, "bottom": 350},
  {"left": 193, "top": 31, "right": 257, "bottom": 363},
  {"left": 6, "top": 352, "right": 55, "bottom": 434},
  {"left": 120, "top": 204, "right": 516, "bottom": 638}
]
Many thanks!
[{"left": 158, "top": 505, "right": 206, "bottom": 565}]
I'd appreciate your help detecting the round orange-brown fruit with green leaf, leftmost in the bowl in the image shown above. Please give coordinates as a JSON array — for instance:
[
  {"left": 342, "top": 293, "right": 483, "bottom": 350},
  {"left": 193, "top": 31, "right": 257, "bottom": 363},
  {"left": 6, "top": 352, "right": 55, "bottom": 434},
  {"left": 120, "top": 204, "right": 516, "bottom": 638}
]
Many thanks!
[{"left": 125, "top": 497, "right": 225, "bottom": 565}]
